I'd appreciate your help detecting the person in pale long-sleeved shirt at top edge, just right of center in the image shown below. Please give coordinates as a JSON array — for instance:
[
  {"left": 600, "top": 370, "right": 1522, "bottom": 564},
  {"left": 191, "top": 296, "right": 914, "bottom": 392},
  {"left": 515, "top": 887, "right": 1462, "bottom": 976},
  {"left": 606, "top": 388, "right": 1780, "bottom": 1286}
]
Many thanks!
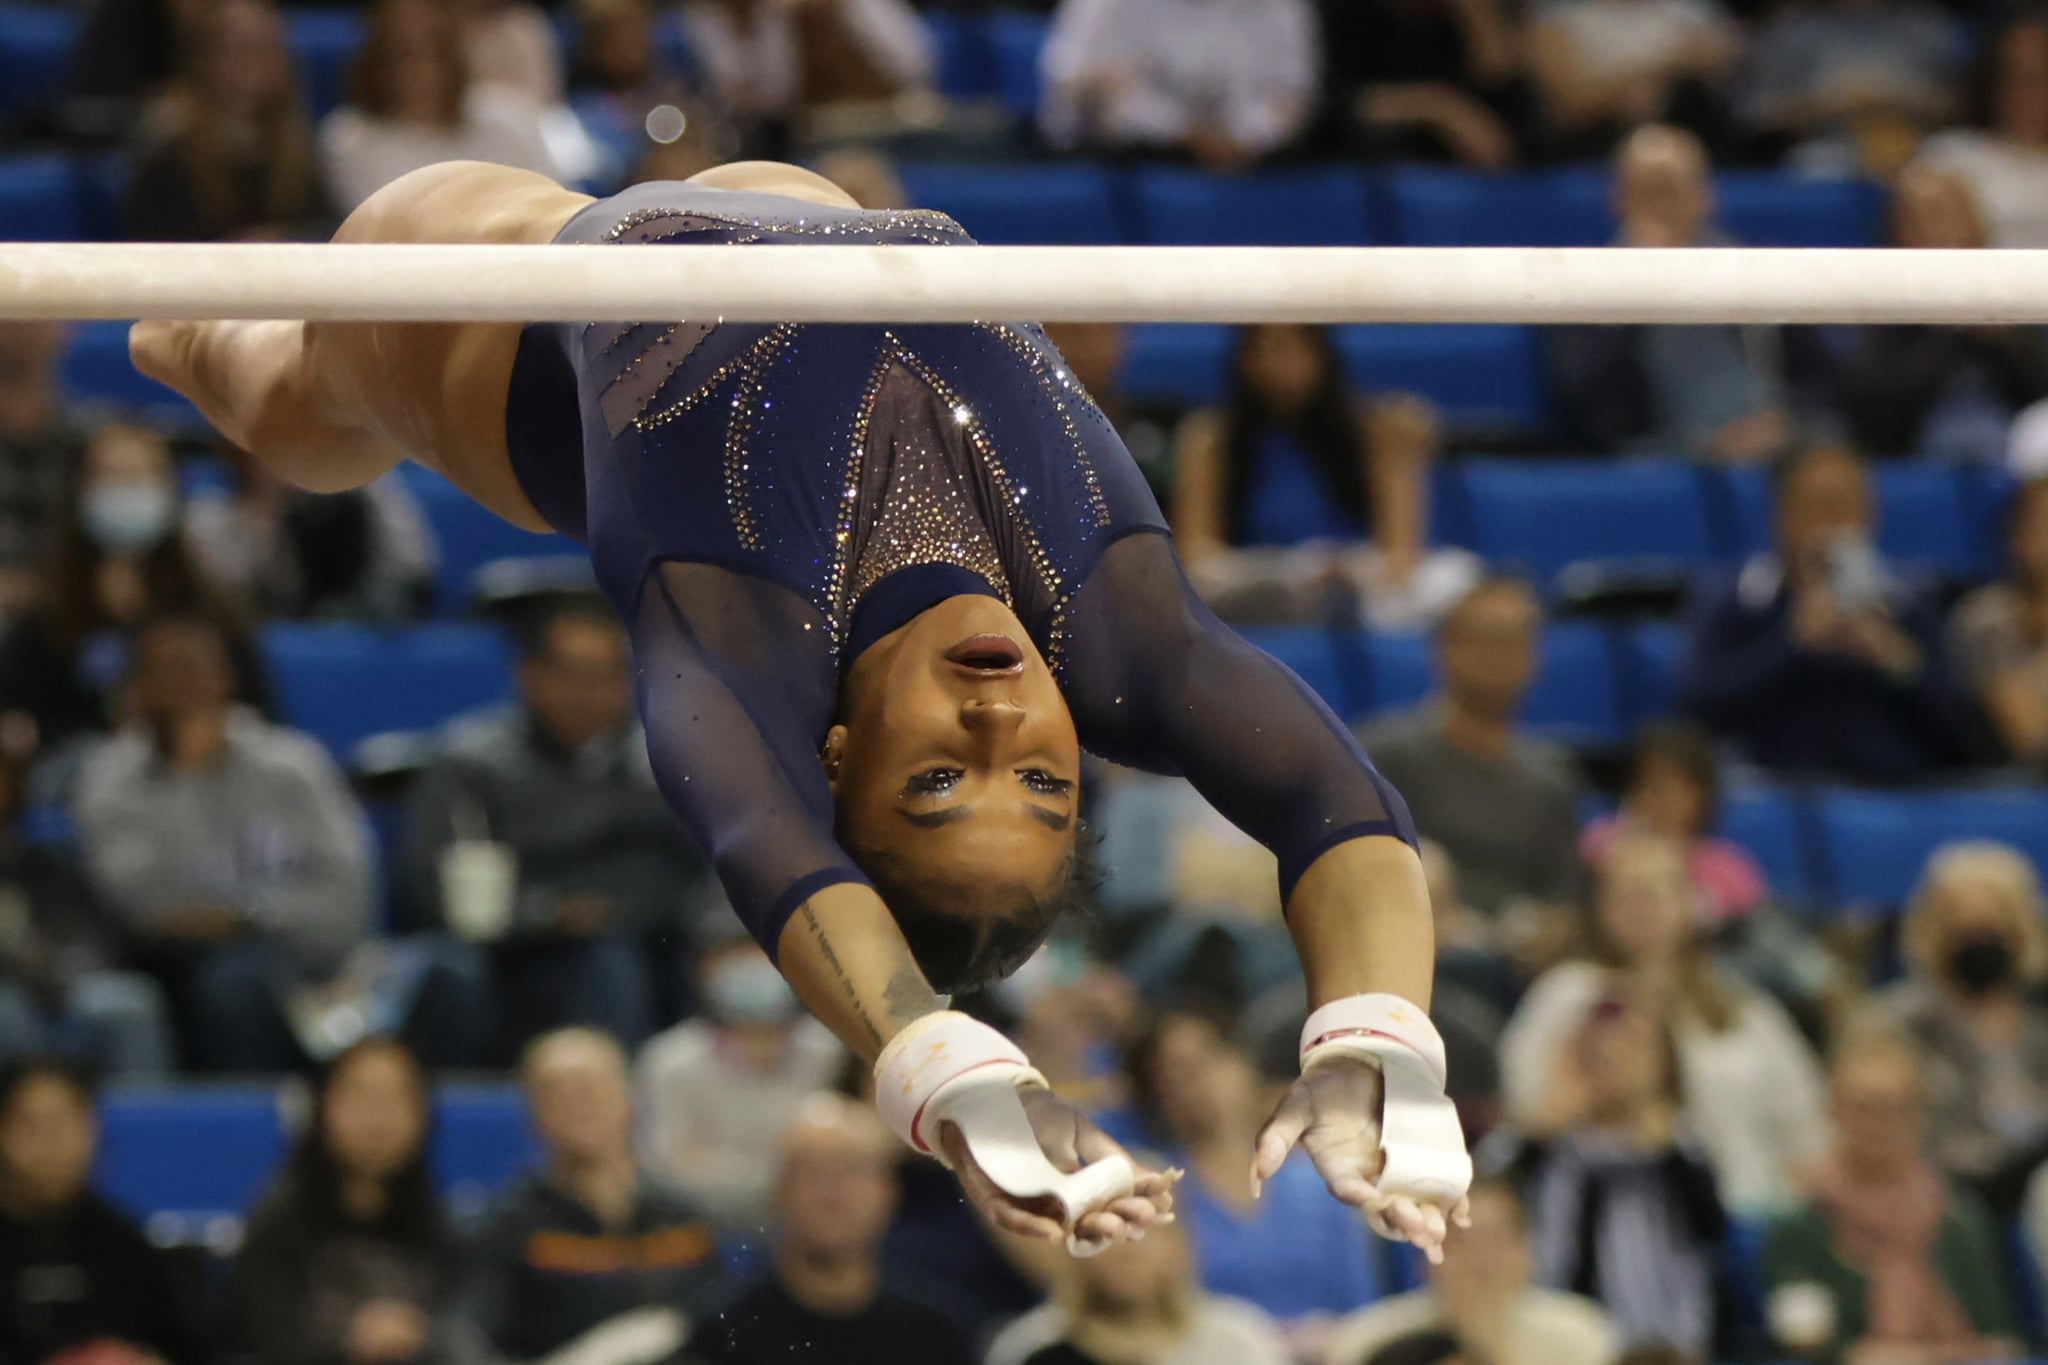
[{"left": 1038, "top": 0, "right": 1321, "bottom": 172}]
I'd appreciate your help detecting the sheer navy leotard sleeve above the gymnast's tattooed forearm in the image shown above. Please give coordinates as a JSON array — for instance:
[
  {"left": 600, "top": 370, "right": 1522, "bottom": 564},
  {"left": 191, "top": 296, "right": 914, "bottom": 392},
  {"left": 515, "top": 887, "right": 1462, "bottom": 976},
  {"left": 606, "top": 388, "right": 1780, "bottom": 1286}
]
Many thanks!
[{"left": 633, "top": 563, "right": 866, "bottom": 958}]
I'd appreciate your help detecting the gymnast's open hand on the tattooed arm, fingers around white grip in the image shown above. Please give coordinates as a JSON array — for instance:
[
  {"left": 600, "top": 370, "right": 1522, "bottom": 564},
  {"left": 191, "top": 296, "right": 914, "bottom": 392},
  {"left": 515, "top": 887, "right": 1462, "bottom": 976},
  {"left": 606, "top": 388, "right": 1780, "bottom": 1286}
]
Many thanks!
[{"left": 938, "top": 1087, "right": 1180, "bottom": 1246}]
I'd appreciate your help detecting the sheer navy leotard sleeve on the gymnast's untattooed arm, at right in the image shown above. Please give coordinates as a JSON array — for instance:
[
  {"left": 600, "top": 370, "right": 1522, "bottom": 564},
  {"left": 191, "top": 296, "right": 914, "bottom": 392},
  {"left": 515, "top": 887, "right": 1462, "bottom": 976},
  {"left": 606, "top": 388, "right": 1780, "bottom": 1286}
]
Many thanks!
[{"left": 1065, "top": 532, "right": 1415, "bottom": 898}]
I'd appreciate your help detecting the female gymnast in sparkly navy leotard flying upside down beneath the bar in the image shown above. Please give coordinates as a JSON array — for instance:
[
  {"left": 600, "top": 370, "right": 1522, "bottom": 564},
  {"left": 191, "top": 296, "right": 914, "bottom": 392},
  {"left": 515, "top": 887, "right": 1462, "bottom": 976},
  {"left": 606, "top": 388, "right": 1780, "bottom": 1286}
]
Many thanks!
[{"left": 131, "top": 162, "right": 1470, "bottom": 1257}]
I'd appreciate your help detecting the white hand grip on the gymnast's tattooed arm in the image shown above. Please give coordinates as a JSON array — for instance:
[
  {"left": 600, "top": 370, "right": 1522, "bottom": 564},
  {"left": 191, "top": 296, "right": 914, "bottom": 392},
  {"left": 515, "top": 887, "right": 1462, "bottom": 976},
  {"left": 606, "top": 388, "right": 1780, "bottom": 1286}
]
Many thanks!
[{"left": 926, "top": 1066, "right": 1137, "bottom": 1257}]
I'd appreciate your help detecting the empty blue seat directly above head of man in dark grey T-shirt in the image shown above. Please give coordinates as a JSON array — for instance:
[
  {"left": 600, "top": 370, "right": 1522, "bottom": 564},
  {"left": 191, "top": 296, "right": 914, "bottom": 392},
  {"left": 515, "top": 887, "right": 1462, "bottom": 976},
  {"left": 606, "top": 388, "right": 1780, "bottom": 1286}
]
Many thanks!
[{"left": 1462, "top": 460, "right": 1714, "bottom": 581}]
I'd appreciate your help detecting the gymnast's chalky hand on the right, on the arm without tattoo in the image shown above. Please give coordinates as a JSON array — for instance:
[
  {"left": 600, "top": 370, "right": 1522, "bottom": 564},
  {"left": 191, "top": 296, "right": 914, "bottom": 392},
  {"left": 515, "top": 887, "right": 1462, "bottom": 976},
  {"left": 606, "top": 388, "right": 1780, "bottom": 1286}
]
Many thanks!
[{"left": 1251, "top": 1060, "right": 1470, "bottom": 1263}]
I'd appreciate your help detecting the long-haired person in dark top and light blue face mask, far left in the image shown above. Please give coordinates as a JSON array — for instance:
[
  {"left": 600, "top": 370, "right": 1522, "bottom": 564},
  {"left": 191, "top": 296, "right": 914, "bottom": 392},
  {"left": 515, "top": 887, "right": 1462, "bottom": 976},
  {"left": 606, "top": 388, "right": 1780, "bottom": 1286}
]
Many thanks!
[{"left": 0, "top": 426, "right": 260, "bottom": 755}]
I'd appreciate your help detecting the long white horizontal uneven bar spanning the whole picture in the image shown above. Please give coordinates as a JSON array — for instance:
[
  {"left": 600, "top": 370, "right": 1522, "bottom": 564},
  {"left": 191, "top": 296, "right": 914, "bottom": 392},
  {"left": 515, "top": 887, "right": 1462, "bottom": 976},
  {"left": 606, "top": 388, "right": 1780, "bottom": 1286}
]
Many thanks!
[{"left": 0, "top": 244, "right": 2048, "bottom": 323}]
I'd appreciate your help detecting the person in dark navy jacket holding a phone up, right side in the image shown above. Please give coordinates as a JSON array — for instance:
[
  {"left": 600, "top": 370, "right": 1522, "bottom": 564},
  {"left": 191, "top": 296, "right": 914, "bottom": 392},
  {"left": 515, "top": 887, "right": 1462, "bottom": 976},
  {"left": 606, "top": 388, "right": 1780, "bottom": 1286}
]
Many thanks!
[{"left": 1677, "top": 446, "right": 1980, "bottom": 782}]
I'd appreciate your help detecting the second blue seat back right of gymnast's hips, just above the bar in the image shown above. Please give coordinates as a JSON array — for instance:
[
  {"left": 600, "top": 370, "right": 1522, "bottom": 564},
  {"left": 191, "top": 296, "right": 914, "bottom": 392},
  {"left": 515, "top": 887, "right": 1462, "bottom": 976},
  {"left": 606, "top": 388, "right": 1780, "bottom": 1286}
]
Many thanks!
[{"left": 1135, "top": 166, "right": 1372, "bottom": 246}]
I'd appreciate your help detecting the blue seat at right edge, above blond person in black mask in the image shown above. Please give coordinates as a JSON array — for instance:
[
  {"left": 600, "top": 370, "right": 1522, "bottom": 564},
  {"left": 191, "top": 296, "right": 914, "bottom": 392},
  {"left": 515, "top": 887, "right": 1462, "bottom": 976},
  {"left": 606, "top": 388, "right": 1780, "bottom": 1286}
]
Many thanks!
[{"left": 1817, "top": 788, "right": 2048, "bottom": 907}]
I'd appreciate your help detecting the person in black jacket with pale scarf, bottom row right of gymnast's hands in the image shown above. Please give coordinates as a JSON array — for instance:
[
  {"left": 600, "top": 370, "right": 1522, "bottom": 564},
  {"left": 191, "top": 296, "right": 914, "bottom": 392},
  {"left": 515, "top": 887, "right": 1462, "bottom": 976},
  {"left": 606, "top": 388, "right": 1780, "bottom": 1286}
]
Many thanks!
[{"left": 1499, "top": 999, "right": 1747, "bottom": 1361}]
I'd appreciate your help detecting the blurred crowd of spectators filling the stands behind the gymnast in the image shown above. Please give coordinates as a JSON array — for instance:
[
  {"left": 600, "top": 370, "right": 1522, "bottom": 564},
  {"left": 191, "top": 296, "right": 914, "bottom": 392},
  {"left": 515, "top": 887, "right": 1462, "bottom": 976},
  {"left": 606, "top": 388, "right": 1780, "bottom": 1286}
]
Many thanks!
[{"left": 0, "top": 0, "right": 2048, "bottom": 1365}]
